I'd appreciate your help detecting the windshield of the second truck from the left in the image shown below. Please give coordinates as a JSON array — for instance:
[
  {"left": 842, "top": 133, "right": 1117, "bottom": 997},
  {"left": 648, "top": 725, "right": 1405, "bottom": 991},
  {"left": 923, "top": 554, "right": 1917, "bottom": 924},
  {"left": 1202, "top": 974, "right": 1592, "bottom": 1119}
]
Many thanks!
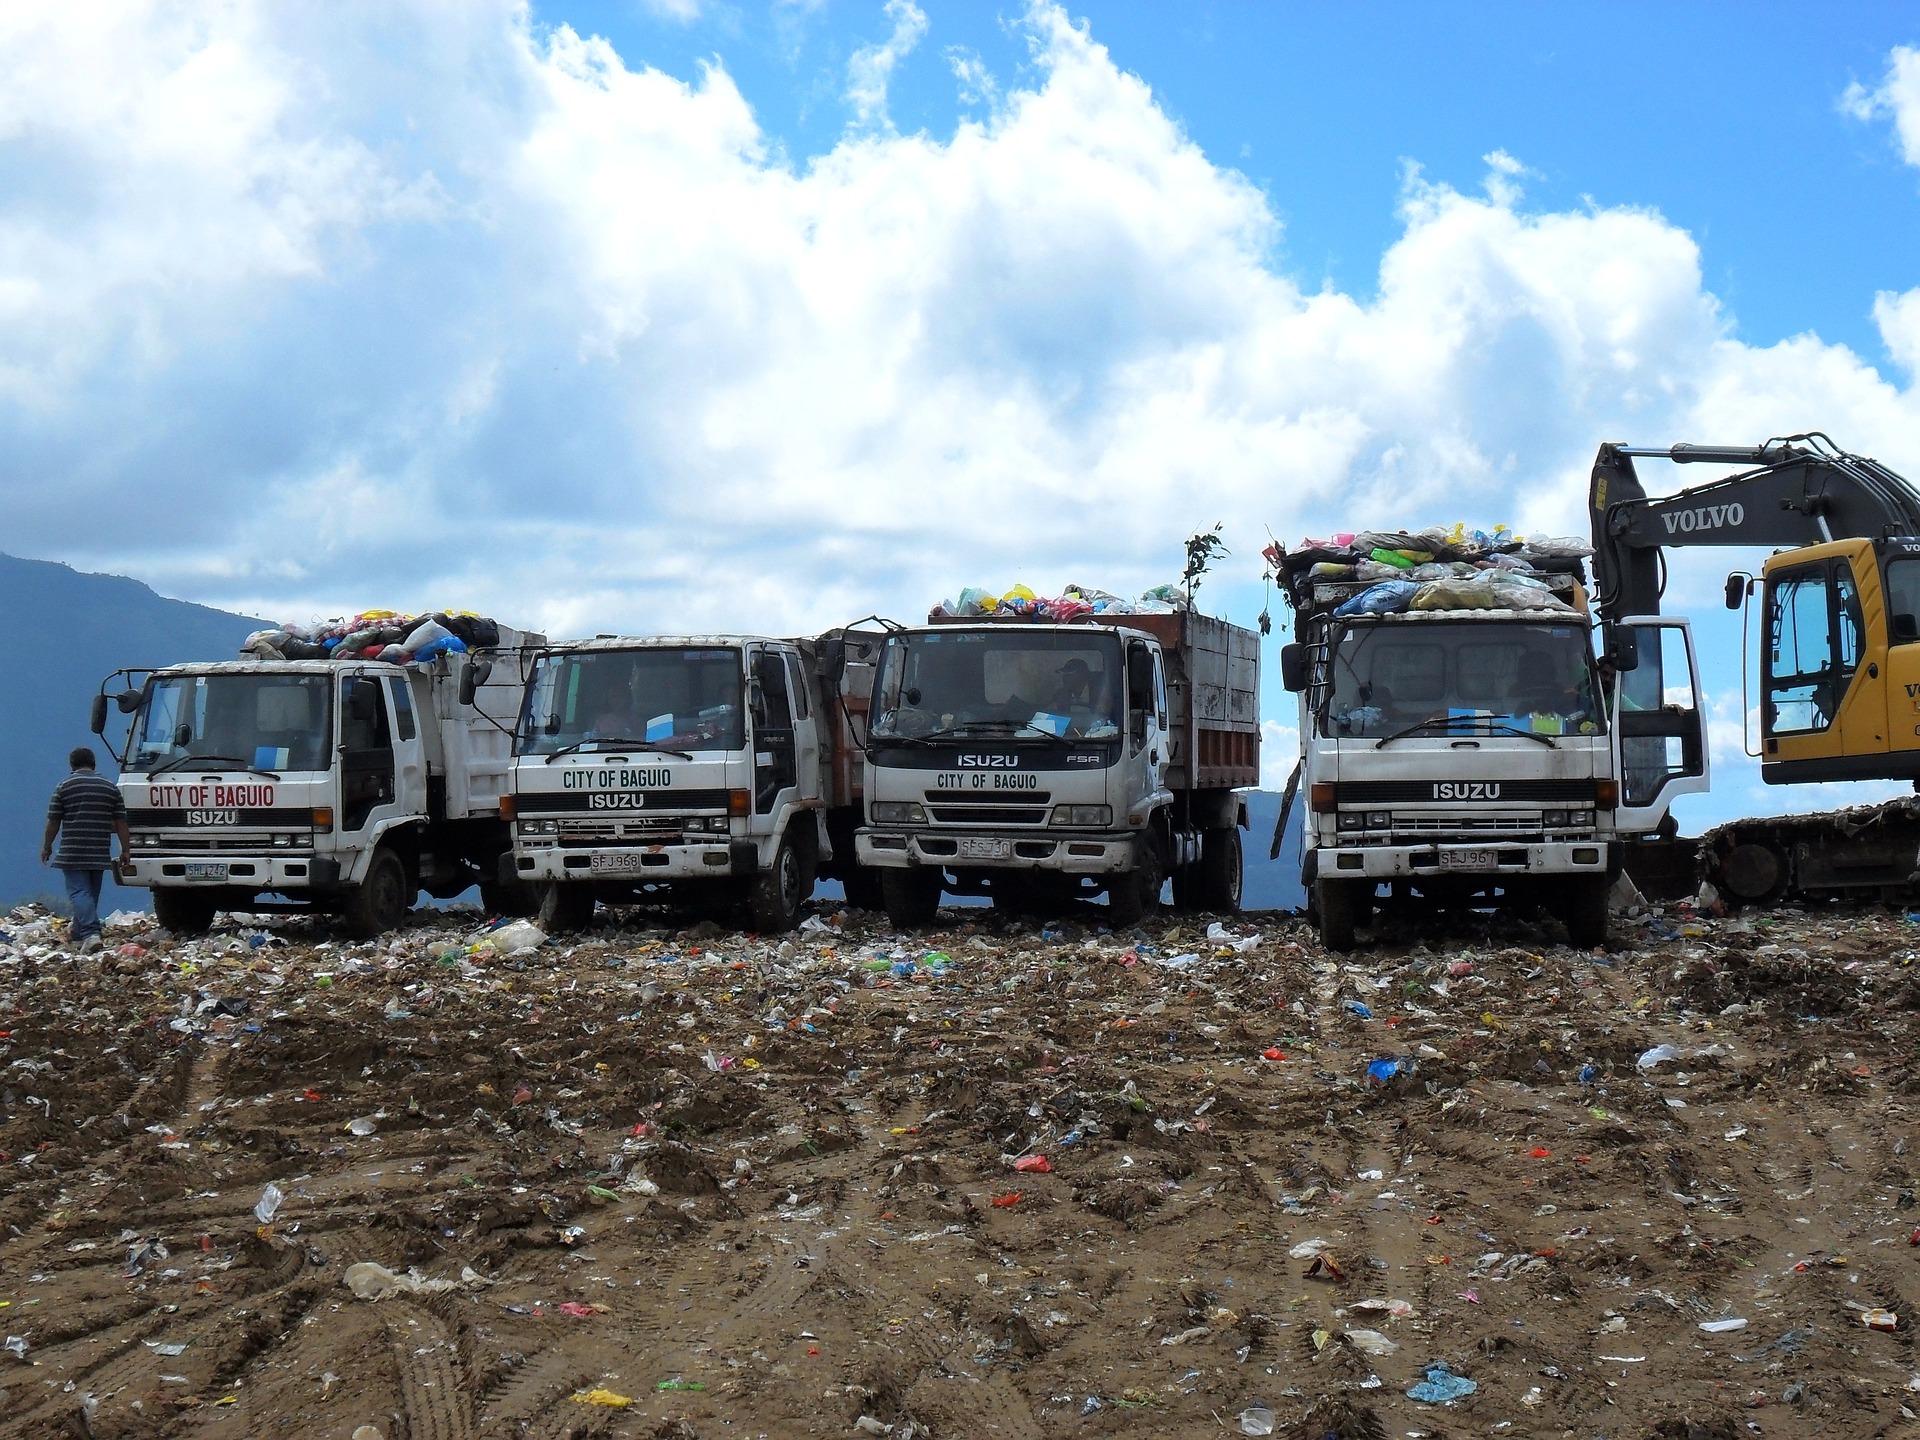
[{"left": 518, "top": 645, "right": 747, "bottom": 755}]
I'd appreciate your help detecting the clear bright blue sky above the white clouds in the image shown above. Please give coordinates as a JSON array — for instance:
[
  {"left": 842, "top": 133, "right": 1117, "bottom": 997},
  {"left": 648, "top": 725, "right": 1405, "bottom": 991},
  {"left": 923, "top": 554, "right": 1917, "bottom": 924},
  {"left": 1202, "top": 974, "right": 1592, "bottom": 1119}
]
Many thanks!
[{"left": 549, "top": 0, "right": 1920, "bottom": 357}]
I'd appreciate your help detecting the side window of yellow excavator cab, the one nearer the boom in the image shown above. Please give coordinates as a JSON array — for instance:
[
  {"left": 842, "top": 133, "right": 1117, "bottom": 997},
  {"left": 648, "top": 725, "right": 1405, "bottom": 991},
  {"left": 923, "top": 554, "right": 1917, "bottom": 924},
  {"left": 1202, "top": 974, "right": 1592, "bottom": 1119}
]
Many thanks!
[{"left": 1763, "top": 561, "right": 1864, "bottom": 735}]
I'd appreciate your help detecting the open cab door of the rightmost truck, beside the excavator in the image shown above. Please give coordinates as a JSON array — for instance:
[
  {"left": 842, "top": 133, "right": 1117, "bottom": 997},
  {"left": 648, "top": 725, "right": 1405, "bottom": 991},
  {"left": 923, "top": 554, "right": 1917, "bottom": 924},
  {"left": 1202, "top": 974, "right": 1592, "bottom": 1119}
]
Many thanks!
[{"left": 1611, "top": 616, "right": 1707, "bottom": 835}]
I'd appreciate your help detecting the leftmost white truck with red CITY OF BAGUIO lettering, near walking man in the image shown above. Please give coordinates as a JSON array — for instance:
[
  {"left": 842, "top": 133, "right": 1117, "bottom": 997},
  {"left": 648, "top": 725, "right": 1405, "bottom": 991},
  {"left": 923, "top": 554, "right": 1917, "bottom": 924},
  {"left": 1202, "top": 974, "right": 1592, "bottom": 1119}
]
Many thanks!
[{"left": 92, "top": 628, "right": 541, "bottom": 935}]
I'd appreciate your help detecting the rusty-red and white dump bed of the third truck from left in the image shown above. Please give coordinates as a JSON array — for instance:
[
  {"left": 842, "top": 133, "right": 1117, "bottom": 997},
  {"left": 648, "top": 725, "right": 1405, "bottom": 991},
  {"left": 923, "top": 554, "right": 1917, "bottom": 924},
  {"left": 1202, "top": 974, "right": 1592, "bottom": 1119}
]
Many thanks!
[{"left": 927, "top": 611, "right": 1260, "bottom": 791}]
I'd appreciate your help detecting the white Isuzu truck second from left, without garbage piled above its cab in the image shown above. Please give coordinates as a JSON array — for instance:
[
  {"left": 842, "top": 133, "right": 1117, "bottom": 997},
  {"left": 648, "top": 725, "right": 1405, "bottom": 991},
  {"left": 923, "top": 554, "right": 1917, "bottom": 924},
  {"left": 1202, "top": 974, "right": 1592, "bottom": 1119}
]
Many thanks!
[{"left": 503, "top": 628, "right": 879, "bottom": 933}]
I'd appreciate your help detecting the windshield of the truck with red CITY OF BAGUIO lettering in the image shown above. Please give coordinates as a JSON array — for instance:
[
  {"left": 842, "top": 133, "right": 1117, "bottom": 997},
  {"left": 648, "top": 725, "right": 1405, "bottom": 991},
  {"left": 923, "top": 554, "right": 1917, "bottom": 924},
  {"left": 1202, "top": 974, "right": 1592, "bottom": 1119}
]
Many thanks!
[{"left": 125, "top": 674, "right": 332, "bottom": 772}]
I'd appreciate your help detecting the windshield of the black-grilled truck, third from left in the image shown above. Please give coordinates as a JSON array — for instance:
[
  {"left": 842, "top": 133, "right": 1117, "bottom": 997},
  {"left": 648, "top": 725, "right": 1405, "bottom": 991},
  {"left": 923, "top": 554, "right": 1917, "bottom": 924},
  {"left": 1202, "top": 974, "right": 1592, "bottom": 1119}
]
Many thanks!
[{"left": 872, "top": 628, "right": 1123, "bottom": 739}]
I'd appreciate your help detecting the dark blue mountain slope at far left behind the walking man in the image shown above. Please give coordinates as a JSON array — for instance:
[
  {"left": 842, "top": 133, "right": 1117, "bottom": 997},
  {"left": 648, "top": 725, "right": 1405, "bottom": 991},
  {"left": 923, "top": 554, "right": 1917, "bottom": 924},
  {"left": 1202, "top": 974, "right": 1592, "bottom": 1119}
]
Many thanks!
[{"left": 0, "top": 555, "right": 263, "bottom": 910}]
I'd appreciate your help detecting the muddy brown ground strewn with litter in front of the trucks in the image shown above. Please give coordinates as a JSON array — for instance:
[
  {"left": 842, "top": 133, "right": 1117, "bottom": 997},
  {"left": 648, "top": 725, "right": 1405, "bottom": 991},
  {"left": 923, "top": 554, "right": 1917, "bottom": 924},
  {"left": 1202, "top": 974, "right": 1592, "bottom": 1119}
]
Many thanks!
[{"left": 0, "top": 890, "right": 1920, "bottom": 1440}]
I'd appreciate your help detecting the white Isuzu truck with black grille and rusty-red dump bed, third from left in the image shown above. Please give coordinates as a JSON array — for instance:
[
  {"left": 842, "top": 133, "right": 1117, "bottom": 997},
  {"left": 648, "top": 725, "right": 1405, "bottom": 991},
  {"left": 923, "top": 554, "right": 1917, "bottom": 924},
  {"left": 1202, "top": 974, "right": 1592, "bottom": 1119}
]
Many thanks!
[{"left": 858, "top": 611, "right": 1260, "bottom": 927}]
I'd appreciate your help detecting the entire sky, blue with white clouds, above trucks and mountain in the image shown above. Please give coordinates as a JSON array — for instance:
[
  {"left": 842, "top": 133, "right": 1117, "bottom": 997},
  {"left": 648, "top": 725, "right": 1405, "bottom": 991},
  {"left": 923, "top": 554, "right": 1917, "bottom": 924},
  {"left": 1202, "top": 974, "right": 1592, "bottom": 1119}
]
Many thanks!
[{"left": 0, "top": 0, "right": 1920, "bottom": 824}]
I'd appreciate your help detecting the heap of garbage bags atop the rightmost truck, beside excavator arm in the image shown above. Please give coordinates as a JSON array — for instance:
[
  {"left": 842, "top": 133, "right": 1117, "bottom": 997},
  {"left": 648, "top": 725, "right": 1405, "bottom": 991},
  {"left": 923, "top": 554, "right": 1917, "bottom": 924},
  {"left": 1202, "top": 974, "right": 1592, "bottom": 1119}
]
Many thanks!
[{"left": 1265, "top": 524, "right": 1594, "bottom": 618}]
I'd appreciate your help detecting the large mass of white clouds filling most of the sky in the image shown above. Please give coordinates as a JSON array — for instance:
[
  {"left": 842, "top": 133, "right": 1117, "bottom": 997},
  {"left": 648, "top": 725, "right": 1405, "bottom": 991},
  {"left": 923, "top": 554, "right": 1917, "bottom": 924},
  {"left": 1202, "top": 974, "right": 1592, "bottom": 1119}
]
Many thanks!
[{"left": 11, "top": 0, "right": 1920, "bottom": 844}]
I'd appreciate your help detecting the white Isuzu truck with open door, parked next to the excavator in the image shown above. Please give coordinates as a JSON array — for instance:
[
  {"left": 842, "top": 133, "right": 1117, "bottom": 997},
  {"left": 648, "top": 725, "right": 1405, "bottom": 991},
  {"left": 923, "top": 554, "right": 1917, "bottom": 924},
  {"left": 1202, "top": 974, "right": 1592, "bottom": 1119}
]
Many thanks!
[{"left": 1275, "top": 557, "right": 1707, "bottom": 950}]
